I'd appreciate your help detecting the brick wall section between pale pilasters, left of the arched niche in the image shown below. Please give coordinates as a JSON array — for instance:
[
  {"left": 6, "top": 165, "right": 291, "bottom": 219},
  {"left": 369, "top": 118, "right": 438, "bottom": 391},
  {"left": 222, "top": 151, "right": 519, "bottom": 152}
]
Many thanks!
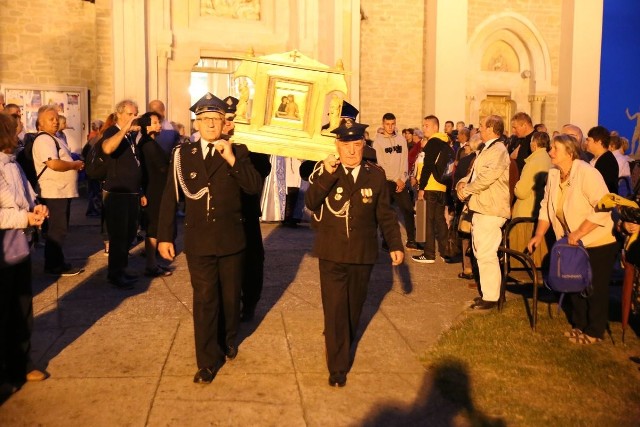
[{"left": 360, "top": 0, "right": 425, "bottom": 132}]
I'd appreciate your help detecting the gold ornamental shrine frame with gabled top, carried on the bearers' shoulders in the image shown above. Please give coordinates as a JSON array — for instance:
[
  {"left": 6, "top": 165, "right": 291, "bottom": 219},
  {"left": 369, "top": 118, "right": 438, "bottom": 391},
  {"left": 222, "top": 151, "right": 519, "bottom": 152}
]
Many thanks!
[{"left": 233, "top": 50, "right": 347, "bottom": 160}]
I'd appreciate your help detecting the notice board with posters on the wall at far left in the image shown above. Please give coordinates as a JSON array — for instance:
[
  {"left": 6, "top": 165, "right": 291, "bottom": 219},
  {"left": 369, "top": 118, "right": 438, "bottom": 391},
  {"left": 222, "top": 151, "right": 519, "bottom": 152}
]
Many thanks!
[{"left": 0, "top": 83, "right": 89, "bottom": 153}]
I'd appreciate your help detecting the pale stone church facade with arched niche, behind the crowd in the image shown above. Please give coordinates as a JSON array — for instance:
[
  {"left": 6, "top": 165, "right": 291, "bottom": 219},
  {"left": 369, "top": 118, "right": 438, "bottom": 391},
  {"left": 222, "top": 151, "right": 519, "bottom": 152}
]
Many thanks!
[{"left": 0, "top": 0, "right": 624, "bottom": 150}]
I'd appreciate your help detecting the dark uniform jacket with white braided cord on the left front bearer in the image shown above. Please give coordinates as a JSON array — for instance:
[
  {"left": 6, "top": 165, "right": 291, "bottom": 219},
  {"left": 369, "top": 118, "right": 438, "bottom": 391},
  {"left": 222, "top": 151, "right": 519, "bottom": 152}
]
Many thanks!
[{"left": 158, "top": 142, "right": 262, "bottom": 256}]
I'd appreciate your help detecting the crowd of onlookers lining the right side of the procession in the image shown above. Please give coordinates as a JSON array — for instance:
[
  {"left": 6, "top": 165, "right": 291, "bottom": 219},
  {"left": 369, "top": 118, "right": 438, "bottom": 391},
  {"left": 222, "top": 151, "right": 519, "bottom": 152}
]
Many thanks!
[{"left": 390, "top": 112, "right": 637, "bottom": 344}]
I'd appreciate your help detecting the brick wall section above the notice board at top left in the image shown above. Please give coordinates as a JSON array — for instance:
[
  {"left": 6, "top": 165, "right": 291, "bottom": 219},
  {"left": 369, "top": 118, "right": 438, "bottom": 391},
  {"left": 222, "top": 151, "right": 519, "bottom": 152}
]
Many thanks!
[{"left": 0, "top": 0, "right": 113, "bottom": 127}]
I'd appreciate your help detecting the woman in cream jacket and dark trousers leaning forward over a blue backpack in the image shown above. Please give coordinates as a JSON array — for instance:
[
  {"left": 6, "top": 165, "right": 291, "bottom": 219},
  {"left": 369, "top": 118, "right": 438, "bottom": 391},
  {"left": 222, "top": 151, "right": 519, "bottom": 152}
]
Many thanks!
[{"left": 527, "top": 134, "right": 618, "bottom": 344}]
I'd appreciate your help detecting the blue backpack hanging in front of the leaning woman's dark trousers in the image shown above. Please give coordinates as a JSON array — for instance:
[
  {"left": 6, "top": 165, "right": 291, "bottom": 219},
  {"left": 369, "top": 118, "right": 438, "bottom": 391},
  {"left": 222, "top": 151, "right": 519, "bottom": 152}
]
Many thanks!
[{"left": 547, "top": 236, "right": 592, "bottom": 310}]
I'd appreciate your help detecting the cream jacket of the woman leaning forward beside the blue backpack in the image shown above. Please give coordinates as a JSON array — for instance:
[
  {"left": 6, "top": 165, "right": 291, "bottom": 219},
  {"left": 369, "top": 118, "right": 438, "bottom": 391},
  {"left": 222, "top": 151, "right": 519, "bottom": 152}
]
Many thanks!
[{"left": 538, "top": 160, "right": 615, "bottom": 247}]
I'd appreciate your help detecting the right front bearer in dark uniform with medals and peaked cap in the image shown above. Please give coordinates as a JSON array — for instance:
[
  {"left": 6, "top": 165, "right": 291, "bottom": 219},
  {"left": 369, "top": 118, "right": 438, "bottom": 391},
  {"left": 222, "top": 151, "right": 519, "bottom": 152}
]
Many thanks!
[{"left": 305, "top": 122, "right": 404, "bottom": 387}]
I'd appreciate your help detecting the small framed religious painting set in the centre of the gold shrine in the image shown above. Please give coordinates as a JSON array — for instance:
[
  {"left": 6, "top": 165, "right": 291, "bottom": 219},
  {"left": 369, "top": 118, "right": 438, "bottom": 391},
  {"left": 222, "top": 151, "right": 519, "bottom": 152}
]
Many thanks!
[{"left": 265, "top": 77, "right": 312, "bottom": 130}]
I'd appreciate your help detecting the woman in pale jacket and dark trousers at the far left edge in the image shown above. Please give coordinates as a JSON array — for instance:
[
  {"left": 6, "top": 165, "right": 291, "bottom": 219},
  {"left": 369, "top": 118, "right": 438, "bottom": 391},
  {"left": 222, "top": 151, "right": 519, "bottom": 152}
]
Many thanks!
[{"left": 0, "top": 114, "right": 48, "bottom": 391}]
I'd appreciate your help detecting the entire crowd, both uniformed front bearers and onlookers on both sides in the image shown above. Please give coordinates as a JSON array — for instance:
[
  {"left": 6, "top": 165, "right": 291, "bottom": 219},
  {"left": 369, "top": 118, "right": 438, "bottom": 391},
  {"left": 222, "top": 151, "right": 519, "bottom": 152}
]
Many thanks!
[{"left": 0, "top": 93, "right": 637, "bottom": 394}]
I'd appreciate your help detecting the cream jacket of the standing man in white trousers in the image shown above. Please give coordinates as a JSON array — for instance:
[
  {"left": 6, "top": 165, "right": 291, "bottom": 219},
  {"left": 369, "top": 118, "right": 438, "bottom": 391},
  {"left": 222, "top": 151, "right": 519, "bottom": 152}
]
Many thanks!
[{"left": 460, "top": 140, "right": 511, "bottom": 218}]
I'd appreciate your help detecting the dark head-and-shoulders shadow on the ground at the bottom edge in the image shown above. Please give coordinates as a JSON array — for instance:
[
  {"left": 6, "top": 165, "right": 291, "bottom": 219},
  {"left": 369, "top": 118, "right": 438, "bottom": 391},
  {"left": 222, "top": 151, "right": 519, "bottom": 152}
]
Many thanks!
[{"left": 362, "top": 358, "right": 506, "bottom": 427}]
